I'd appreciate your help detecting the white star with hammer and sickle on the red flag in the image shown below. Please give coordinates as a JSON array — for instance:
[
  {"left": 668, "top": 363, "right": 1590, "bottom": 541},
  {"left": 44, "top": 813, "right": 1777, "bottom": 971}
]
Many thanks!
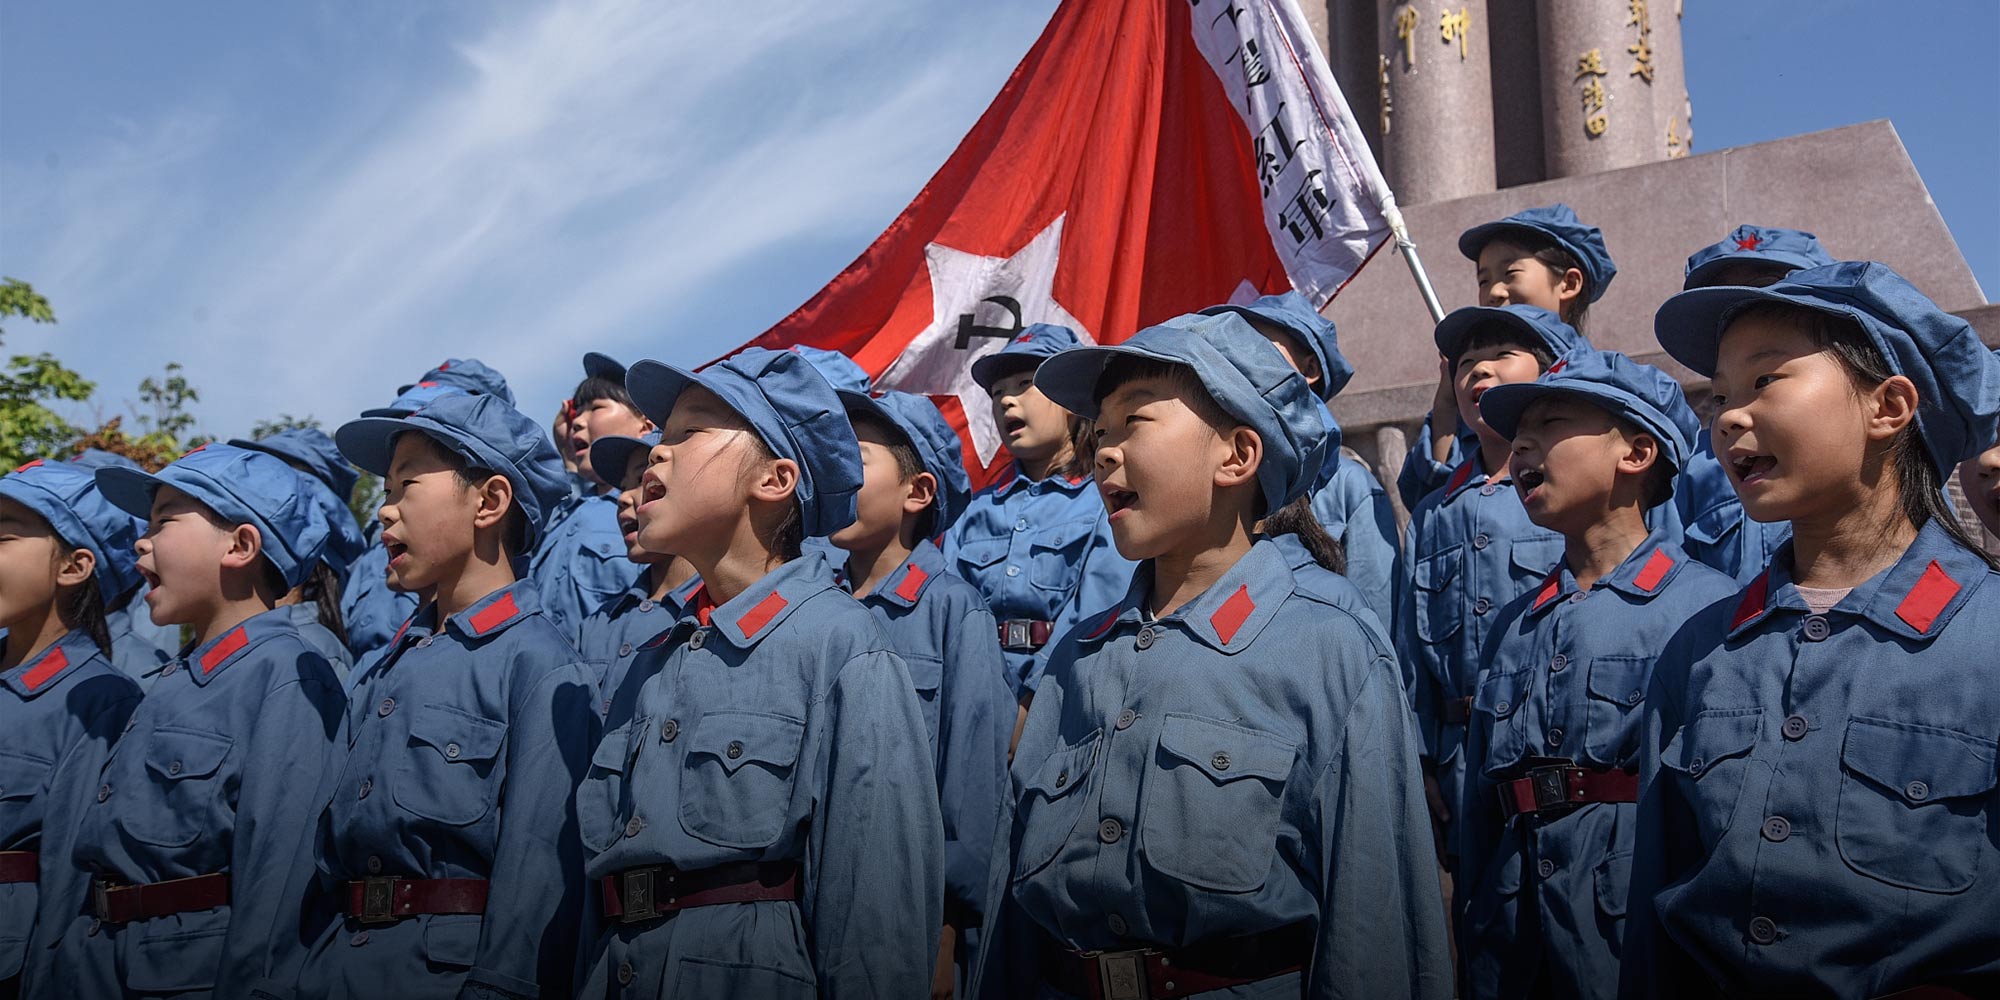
[{"left": 876, "top": 216, "right": 1096, "bottom": 464}]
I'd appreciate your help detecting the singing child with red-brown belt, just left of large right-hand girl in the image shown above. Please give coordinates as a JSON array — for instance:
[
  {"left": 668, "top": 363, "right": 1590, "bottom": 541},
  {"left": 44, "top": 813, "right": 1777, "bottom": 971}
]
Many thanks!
[{"left": 1456, "top": 350, "right": 1734, "bottom": 1000}]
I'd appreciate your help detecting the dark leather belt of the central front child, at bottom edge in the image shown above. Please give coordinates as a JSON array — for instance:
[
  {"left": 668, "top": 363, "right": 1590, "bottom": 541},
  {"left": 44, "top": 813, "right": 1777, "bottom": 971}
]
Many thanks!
[{"left": 1042, "top": 922, "right": 1312, "bottom": 1000}]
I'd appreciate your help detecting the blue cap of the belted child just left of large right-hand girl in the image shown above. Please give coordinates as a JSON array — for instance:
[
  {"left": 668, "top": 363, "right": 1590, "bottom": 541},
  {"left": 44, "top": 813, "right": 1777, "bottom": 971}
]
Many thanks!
[{"left": 1480, "top": 348, "right": 1702, "bottom": 480}]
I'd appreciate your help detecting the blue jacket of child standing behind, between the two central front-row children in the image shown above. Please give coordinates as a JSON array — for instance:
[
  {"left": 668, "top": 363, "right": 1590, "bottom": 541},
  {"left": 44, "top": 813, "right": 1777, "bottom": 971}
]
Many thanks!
[{"left": 860, "top": 542, "right": 1016, "bottom": 926}]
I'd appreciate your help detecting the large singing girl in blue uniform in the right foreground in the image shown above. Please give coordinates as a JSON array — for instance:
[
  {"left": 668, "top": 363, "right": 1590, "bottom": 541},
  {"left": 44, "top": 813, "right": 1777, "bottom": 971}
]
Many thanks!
[{"left": 1622, "top": 262, "right": 2000, "bottom": 998}]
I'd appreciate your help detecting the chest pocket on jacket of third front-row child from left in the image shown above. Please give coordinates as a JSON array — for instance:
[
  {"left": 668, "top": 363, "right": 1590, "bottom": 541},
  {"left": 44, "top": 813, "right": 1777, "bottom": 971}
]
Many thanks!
[{"left": 394, "top": 704, "right": 506, "bottom": 826}]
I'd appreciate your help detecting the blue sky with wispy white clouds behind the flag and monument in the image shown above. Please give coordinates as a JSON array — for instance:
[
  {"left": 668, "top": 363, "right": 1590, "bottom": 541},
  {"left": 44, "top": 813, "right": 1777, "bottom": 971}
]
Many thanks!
[{"left": 0, "top": 0, "right": 2000, "bottom": 436}]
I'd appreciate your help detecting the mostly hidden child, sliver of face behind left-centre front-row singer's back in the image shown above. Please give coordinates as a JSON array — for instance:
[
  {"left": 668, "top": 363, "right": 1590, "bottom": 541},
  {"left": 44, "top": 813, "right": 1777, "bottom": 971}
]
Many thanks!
[{"left": 578, "top": 430, "right": 702, "bottom": 728}]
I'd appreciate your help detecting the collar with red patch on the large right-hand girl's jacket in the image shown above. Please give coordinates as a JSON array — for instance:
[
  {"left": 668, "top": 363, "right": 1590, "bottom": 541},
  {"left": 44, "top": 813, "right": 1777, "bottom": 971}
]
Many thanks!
[{"left": 1730, "top": 522, "right": 1992, "bottom": 640}]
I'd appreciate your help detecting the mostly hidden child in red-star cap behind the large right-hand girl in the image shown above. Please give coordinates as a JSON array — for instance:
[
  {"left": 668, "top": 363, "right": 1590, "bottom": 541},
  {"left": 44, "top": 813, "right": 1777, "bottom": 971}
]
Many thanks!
[{"left": 1674, "top": 226, "right": 1834, "bottom": 584}]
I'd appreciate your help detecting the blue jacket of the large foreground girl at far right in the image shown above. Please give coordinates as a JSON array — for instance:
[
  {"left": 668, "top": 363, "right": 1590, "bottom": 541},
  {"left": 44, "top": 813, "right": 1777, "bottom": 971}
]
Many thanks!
[{"left": 1622, "top": 524, "right": 2000, "bottom": 998}]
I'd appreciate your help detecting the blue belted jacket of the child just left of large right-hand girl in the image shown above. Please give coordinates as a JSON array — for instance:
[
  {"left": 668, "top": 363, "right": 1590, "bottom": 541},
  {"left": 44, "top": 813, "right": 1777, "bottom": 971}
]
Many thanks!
[{"left": 1456, "top": 532, "right": 1736, "bottom": 998}]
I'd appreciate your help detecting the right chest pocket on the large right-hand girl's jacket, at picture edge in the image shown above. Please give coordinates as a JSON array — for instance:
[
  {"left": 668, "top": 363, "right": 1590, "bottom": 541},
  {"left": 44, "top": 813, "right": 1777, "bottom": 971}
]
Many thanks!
[{"left": 1834, "top": 718, "right": 1996, "bottom": 892}]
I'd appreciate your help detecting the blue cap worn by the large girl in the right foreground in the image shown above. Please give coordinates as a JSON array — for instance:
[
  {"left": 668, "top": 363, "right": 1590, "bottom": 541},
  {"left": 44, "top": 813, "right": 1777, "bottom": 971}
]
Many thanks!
[{"left": 1652, "top": 260, "right": 2000, "bottom": 476}]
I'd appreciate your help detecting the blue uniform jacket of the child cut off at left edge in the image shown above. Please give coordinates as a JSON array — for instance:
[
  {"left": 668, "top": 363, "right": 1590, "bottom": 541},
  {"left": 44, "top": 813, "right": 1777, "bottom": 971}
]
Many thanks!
[{"left": 0, "top": 632, "right": 140, "bottom": 982}]
